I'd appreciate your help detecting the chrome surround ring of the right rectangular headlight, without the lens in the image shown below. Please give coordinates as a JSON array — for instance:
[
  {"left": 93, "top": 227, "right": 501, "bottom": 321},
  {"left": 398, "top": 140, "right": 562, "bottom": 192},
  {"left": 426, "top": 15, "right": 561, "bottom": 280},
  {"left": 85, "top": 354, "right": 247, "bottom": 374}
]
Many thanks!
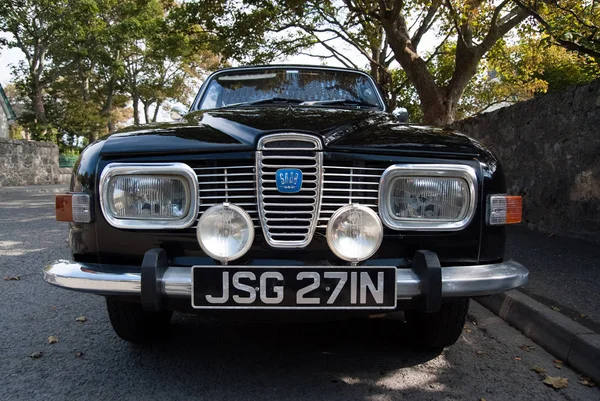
[{"left": 379, "top": 164, "right": 477, "bottom": 231}]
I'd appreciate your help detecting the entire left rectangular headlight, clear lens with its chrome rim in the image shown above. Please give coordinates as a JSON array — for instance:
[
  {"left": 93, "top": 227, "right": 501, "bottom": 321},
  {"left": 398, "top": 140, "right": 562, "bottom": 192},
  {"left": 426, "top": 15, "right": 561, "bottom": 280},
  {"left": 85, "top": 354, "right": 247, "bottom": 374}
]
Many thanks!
[{"left": 100, "top": 163, "right": 198, "bottom": 229}]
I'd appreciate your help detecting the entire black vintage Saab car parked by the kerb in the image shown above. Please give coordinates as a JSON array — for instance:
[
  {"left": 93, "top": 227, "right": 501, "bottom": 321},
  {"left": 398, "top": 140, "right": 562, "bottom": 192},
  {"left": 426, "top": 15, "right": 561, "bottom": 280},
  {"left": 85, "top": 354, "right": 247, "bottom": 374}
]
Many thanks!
[{"left": 44, "top": 65, "right": 528, "bottom": 347}]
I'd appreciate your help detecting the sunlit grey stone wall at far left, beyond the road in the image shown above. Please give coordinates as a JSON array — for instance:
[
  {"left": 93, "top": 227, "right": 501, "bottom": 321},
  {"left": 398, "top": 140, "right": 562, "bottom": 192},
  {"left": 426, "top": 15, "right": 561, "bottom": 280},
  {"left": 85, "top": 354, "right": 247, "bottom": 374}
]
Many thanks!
[{"left": 0, "top": 138, "right": 60, "bottom": 187}]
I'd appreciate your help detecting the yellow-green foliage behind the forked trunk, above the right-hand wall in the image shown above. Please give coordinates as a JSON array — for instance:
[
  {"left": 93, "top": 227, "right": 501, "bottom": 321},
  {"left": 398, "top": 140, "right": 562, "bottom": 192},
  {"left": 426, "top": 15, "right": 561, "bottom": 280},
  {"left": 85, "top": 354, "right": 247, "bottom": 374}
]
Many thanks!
[{"left": 384, "top": 30, "right": 600, "bottom": 122}]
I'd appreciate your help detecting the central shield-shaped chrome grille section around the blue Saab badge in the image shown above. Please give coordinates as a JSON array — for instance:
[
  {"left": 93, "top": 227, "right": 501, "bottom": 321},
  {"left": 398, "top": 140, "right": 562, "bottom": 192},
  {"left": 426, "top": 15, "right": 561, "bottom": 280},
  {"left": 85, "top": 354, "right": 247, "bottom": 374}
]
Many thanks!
[{"left": 256, "top": 134, "right": 323, "bottom": 248}]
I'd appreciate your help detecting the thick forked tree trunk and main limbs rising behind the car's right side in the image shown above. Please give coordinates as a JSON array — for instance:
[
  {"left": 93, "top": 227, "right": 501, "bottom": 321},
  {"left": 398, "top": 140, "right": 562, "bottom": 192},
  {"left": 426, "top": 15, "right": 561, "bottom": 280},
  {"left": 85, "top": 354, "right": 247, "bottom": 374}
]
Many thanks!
[{"left": 324, "top": 0, "right": 528, "bottom": 125}]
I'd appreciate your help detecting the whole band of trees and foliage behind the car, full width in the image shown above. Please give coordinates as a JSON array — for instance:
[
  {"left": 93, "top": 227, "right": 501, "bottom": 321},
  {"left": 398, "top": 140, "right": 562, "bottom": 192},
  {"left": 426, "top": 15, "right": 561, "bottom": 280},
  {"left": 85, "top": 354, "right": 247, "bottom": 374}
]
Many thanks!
[{"left": 0, "top": 0, "right": 600, "bottom": 145}]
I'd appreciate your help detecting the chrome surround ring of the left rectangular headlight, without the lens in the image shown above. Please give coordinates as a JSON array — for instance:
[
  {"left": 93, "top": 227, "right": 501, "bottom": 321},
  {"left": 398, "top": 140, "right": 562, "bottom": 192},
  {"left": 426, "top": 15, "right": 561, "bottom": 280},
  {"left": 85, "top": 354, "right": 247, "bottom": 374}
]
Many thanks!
[{"left": 99, "top": 163, "right": 198, "bottom": 230}]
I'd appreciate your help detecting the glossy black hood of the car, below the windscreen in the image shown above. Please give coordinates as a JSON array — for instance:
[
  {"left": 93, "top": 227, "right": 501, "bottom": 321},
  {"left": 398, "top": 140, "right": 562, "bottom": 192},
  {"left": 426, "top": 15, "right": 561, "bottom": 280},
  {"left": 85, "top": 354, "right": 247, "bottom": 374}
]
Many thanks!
[{"left": 101, "top": 106, "right": 481, "bottom": 157}]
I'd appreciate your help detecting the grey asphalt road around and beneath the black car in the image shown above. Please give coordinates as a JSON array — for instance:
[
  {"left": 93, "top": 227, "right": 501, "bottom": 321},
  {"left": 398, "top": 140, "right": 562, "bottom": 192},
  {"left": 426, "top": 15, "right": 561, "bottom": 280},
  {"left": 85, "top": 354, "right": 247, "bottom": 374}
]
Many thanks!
[{"left": 0, "top": 191, "right": 600, "bottom": 401}]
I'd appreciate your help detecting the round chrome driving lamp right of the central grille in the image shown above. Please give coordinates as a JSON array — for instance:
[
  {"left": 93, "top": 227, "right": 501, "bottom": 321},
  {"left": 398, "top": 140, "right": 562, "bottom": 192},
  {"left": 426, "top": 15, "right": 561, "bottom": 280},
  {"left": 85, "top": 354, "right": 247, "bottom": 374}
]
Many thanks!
[{"left": 327, "top": 205, "right": 383, "bottom": 263}]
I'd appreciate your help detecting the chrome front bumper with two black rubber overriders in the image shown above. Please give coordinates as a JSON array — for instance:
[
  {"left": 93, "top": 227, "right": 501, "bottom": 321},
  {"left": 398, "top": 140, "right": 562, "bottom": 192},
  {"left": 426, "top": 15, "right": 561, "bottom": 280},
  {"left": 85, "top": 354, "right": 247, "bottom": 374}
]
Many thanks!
[{"left": 44, "top": 249, "right": 529, "bottom": 311}]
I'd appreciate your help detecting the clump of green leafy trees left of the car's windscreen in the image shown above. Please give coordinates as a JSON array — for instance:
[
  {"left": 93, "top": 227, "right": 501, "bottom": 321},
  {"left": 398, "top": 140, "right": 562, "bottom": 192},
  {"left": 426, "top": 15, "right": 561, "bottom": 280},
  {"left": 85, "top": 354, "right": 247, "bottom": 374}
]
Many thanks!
[{"left": 0, "top": 0, "right": 221, "bottom": 142}]
